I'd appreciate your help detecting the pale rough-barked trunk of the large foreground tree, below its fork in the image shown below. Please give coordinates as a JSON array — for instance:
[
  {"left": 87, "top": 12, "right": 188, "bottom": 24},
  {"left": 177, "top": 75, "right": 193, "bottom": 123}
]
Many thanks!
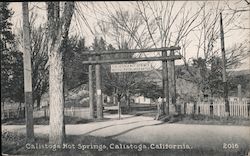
[{"left": 49, "top": 48, "right": 65, "bottom": 144}]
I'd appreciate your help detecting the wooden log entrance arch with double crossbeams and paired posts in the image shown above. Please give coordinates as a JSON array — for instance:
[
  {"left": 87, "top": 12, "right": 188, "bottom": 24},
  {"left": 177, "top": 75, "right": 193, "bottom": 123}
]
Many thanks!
[{"left": 82, "top": 46, "right": 182, "bottom": 119}]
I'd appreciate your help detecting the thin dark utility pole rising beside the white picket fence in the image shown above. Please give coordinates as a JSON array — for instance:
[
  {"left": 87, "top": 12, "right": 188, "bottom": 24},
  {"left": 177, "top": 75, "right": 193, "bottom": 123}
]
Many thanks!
[{"left": 220, "top": 13, "right": 230, "bottom": 116}]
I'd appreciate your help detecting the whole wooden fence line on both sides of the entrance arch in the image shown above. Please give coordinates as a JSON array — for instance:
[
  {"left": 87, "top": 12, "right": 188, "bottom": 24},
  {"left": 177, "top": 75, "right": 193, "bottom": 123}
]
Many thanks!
[{"left": 1, "top": 99, "right": 250, "bottom": 119}]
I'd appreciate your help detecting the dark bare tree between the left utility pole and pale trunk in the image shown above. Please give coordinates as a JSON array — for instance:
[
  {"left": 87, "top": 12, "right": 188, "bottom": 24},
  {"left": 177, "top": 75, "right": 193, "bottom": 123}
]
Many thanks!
[{"left": 16, "top": 13, "right": 49, "bottom": 108}]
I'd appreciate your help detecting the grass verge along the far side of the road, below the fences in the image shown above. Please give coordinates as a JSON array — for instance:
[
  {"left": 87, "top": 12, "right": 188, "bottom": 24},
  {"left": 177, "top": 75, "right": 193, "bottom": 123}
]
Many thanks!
[{"left": 2, "top": 110, "right": 250, "bottom": 126}]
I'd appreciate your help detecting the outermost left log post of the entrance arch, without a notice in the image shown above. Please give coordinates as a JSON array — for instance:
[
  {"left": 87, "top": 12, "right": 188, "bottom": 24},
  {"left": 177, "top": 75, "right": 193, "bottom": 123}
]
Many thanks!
[{"left": 89, "top": 57, "right": 95, "bottom": 119}]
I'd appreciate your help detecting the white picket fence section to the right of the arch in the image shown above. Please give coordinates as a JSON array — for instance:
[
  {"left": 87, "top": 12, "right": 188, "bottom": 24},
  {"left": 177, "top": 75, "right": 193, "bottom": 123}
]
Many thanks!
[{"left": 185, "top": 99, "right": 250, "bottom": 118}]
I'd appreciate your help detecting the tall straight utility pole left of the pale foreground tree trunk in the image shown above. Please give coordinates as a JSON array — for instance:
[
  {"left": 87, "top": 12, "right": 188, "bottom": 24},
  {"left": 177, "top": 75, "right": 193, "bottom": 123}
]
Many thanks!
[{"left": 22, "top": 2, "right": 34, "bottom": 142}]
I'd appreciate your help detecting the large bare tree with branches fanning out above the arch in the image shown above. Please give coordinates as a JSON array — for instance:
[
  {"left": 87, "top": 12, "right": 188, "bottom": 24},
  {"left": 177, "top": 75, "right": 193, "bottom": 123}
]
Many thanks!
[{"left": 89, "top": 1, "right": 204, "bottom": 112}]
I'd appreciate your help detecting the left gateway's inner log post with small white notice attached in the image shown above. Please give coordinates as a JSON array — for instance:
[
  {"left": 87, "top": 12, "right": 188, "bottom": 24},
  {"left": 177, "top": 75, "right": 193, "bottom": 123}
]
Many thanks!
[{"left": 95, "top": 55, "right": 103, "bottom": 119}]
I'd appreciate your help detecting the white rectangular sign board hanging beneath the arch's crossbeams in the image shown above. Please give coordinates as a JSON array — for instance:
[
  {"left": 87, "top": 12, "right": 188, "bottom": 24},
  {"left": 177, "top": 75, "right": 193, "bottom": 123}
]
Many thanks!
[{"left": 111, "top": 63, "right": 152, "bottom": 73}]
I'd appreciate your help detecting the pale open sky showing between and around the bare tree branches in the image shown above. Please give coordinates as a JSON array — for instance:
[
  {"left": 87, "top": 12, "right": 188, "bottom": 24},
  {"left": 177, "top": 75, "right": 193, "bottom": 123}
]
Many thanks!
[{"left": 10, "top": 0, "right": 250, "bottom": 69}]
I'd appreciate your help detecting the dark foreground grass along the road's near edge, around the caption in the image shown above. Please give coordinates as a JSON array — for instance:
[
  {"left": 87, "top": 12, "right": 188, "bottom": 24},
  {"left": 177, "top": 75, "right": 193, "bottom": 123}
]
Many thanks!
[{"left": 2, "top": 132, "right": 247, "bottom": 156}]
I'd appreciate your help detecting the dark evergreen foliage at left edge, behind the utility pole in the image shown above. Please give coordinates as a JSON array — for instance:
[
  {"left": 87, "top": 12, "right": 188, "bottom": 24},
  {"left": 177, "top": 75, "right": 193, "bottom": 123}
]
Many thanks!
[{"left": 0, "top": 2, "right": 24, "bottom": 102}]
